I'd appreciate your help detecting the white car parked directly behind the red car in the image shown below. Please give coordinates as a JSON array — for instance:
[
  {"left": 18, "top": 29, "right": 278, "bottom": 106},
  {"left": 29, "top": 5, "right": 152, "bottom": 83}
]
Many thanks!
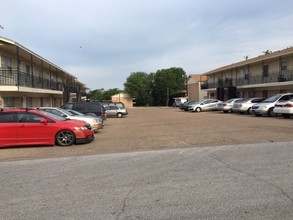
[{"left": 38, "top": 107, "right": 103, "bottom": 132}]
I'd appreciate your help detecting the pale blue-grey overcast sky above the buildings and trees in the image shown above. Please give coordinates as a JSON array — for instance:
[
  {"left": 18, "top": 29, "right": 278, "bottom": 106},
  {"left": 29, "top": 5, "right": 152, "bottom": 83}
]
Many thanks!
[{"left": 0, "top": 0, "right": 293, "bottom": 90}]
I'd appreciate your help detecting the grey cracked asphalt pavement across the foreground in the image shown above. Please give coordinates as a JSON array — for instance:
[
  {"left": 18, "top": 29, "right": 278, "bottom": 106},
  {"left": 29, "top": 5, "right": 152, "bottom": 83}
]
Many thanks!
[{"left": 0, "top": 142, "right": 293, "bottom": 220}]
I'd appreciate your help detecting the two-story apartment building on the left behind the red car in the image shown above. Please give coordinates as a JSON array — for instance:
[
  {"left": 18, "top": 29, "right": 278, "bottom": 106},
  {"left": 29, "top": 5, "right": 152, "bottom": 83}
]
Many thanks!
[{"left": 0, "top": 37, "right": 87, "bottom": 107}]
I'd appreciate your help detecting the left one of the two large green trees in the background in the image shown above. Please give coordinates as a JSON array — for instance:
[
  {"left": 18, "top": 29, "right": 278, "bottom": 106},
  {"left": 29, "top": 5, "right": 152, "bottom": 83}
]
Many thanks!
[{"left": 124, "top": 72, "right": 153, "bottom": 106}]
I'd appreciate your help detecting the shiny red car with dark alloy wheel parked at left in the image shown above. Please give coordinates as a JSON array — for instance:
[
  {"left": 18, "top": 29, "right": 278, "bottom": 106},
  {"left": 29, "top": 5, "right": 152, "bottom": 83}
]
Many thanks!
[{"left": 0, "top": 109, "right": 94, "bottom": 147}]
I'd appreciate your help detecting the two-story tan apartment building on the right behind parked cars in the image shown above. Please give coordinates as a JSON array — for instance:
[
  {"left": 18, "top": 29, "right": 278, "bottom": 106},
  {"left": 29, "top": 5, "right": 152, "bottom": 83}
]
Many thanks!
[{"left": 203, "top": 47, "right": 293, "bottom": 100}]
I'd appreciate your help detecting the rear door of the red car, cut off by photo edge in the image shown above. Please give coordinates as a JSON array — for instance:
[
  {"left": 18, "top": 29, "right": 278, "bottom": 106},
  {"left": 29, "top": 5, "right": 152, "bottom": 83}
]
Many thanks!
[{"left": 0, "top": 112, "right": 16, "bottom": 147}]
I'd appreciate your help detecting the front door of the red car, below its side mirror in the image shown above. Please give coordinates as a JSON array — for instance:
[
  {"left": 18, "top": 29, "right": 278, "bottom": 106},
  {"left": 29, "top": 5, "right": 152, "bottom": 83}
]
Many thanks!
[{"left": 16, "top": 112, "right": 54, "bottom": 145}]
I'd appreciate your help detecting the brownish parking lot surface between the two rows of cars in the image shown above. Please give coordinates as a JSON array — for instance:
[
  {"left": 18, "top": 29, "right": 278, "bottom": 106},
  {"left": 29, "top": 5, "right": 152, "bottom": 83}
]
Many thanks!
[{"left": 0, "top": 107, "right": 293, "bottom": 161}]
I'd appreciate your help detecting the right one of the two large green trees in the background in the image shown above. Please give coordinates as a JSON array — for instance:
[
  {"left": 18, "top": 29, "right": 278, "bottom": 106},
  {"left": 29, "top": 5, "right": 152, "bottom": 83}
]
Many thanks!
[{"left": 153, "top": 67, "right": 186, "bottom": 106}]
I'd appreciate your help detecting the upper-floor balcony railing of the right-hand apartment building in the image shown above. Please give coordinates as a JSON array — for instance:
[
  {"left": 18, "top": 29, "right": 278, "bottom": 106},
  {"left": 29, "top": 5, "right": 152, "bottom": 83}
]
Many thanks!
[{"left": 205, "top": 70, "right": 293, "bottom": 89}]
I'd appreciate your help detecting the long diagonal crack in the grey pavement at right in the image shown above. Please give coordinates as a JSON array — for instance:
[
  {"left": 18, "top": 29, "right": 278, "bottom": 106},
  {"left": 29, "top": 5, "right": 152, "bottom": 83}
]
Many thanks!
[{"left": 203, "top": 150, "right": 293, "bottom": 203}]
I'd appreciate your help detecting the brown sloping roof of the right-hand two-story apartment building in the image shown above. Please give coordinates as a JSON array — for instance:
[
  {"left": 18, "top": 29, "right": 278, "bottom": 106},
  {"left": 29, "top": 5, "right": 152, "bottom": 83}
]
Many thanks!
[{"left": 204, "top": 47, "right": 293, "bottom": 75}]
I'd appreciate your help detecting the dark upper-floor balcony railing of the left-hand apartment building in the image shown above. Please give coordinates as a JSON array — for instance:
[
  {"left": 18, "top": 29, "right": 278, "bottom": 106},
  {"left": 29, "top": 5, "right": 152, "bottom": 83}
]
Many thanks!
[{"left": 0, "top": 69, "right": 64, "bottom": 91}]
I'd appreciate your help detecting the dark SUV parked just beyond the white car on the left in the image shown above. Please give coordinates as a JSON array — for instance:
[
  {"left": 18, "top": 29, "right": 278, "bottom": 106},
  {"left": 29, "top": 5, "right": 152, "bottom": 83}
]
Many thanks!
[{"left": 61, "top": 101, "right": 106, "bottom": 119}]
